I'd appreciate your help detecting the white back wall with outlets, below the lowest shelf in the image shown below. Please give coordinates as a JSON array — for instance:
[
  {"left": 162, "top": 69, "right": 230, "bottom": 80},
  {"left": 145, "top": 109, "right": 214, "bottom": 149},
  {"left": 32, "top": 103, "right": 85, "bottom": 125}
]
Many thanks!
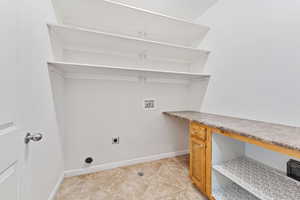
[{"left": 64, "top": 79, "right": 206, "bottom": 172}]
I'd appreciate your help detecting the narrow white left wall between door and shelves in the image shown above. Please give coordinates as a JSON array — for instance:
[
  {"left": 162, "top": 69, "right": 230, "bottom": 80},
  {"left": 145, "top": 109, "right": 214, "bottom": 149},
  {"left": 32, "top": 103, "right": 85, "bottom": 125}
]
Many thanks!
[{"left": 16, "top": 0, "right": 63, "bottom": 200}]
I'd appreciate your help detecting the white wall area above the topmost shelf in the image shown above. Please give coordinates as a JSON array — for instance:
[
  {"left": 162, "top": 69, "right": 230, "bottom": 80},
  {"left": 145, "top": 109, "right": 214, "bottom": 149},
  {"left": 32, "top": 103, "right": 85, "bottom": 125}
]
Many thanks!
[{"left": 112, "top": 0, "right": 216, "bottom": 21}]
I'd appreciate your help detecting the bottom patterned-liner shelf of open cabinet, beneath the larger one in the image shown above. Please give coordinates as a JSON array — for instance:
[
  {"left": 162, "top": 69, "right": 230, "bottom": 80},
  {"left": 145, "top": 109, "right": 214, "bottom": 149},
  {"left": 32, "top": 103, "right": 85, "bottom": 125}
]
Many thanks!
[{"left": 213, "top": 183, "right": 259, "bottom": 200}]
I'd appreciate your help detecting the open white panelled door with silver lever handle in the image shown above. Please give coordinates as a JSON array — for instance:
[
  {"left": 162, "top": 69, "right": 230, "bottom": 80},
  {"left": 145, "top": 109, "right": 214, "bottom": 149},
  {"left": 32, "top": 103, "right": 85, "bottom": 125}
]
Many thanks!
[{"left": 0, "top": 0, "right": 44, "bottom": 200}]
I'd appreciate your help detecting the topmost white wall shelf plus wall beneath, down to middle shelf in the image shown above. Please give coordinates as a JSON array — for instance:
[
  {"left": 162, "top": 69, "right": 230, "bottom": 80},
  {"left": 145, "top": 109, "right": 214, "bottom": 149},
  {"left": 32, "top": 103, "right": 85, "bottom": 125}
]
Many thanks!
[{"left": 54, "top": 0, "right": 209, "bottom": 47}]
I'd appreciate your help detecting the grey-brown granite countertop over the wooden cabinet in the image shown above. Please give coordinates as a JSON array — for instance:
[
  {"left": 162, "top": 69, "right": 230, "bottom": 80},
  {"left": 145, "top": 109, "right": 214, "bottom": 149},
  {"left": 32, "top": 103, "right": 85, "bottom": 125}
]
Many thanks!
[{"left": 164, "top": 111, "right": 300, "bottom": 151}]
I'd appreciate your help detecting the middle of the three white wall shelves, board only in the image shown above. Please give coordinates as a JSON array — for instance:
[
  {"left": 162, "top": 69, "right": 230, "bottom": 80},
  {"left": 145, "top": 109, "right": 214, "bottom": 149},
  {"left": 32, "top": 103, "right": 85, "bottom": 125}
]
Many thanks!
[{"left": 48, "top": 24, "right": 209, "bottom": 62}]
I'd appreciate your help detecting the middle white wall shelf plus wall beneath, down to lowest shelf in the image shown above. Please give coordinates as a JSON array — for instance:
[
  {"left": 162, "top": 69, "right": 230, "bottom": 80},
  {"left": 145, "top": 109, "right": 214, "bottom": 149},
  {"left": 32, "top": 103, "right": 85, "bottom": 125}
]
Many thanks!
[{"left": 48, "top": 24, "right": 209, "bottom": 71}]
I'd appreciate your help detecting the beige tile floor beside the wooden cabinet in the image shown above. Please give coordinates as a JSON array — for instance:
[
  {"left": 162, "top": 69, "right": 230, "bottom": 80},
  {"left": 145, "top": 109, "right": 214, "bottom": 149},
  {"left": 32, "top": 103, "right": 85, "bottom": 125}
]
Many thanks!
[{"left": 56, "top": 156, "right": 206, "bottom": 200}]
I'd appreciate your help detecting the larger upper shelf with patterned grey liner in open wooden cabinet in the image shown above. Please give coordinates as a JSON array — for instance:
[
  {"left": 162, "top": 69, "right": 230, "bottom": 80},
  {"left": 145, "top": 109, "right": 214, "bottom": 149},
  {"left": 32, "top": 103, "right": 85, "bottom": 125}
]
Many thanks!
[{"left": 213, "top": 157, "right": 300, "bottom": 200}]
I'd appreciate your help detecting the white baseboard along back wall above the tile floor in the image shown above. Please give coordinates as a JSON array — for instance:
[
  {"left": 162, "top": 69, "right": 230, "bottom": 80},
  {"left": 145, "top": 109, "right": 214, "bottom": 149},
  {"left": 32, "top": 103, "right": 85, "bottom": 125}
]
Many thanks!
[{"left": 65, "top": 150, "right": 189, "bottom": 177}]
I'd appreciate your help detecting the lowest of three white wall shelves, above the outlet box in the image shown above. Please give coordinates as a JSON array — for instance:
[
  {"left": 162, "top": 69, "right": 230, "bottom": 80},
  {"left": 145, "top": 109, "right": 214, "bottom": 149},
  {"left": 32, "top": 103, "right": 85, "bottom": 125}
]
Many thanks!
[{"left": 48, "top": 62, "right": 210, "bottom": 82}]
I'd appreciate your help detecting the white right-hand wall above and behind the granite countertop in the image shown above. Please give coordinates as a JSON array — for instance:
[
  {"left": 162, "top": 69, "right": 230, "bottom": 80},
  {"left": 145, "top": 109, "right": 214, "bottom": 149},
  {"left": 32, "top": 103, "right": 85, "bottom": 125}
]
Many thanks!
[{"left": 198, "top": 0, "right": 300, "bottom": 170}]
